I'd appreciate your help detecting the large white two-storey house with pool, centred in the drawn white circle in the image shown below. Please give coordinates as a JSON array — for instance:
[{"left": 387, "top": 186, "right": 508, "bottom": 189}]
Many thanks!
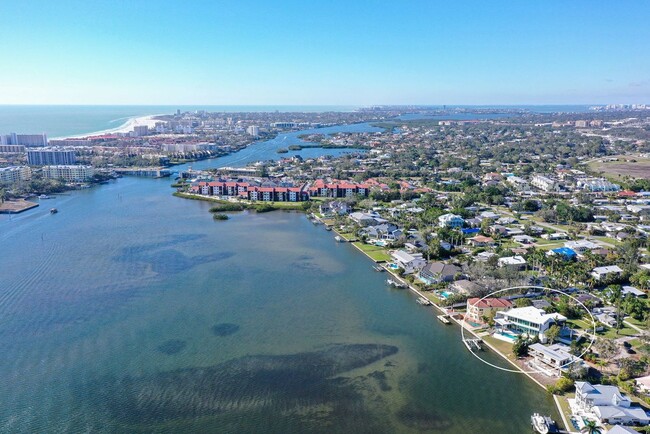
[{"left": 494, "top": 306, "right": 566, "bottom": 343}]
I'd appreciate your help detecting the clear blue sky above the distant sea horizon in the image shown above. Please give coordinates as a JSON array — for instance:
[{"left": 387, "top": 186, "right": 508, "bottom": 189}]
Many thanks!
[{"left": 0, "top": 0, "right": 650, "bottom": 105}]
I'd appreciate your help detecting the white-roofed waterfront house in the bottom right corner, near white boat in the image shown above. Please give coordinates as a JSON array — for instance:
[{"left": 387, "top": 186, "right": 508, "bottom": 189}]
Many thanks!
[{"left": 575, "top": 381, "right": 650, "bottom": 425}]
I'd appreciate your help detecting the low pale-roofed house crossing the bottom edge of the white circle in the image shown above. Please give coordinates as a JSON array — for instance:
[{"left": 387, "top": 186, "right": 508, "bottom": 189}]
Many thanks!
[{"left": 528, "top": 343, "right": 588, "bottom": 377}]
